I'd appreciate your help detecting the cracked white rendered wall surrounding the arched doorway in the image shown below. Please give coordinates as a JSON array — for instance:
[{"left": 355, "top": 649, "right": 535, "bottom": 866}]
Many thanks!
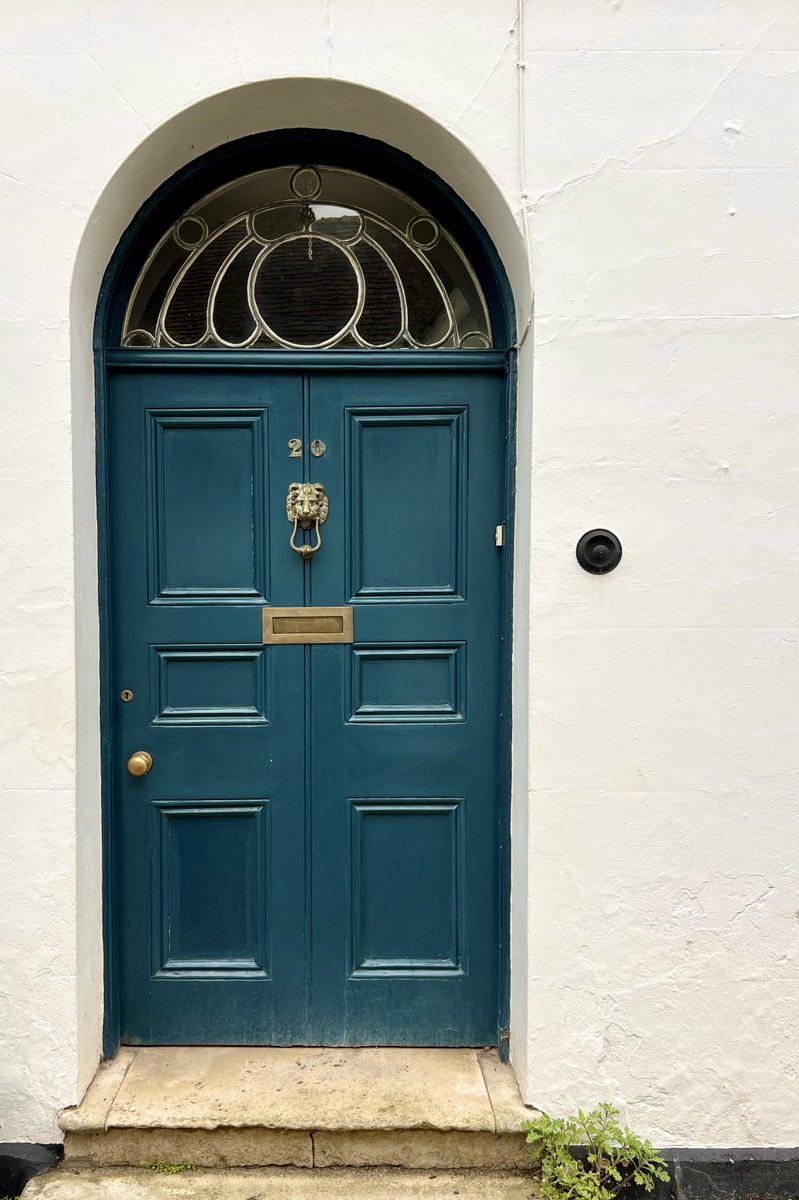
[{"left": 0, "top": 0, "right": 799, "bottom": 1146}]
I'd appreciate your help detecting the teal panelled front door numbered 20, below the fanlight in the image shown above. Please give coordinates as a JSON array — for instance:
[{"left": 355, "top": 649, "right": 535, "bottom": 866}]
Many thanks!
[{"left": 108, "top": 355, "right": 505, "bottom": 1045}]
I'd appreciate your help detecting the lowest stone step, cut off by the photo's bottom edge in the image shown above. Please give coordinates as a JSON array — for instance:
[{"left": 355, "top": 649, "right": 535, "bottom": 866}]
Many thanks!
[{"left": 23, "top": 1166, "right": 534, "bottom": 1200}]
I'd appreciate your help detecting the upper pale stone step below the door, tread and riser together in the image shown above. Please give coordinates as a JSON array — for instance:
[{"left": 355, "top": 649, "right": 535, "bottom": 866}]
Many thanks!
[{"left": 61, "top": 1046, "right": 533, "bottom": 1170}]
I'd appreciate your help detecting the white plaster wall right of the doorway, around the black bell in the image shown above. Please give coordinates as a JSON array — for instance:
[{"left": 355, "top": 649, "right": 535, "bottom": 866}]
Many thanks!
[{"left": 525, "top": 0, "right": 799, "bottom": 1145}]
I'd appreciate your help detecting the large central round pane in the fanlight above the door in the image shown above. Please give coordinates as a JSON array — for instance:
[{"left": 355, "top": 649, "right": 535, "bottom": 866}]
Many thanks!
[{"left": 251, "top": 235, "right": 362, "bottom": 347}]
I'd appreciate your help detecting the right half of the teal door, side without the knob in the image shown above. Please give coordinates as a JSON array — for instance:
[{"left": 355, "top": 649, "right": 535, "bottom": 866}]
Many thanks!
[{"left": 305, "top": 372, "right": 504, "bottom": 1045}]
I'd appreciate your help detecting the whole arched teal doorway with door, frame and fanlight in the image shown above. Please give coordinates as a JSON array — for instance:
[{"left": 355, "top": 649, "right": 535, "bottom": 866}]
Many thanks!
[{"left": 97, "top": 132, "right": 513, "bottom": 1052}]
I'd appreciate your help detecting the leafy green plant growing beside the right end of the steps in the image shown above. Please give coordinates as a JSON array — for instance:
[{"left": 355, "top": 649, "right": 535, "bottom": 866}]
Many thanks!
[{"left": 524, "top": 1104, "right": 668, "bottom": 1200}]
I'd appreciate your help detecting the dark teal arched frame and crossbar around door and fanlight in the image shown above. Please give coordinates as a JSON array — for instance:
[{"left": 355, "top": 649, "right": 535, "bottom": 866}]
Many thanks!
[{"left": 94, "top": 130, "right": 517, "bottom": 1061}]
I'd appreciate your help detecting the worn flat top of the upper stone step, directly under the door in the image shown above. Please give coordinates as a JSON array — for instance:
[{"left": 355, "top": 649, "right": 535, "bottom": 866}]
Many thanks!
[{"left": 61, "top": 1046, "right": 531, "bottom": 1133}]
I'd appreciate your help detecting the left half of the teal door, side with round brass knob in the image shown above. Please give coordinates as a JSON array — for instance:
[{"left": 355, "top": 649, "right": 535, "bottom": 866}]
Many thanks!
[{"left": 109, "top": 371, "right": 307, "bottom": 1044}]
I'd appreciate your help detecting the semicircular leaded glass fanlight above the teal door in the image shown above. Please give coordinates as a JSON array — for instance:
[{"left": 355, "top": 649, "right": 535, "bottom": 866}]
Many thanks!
[{"left": 122, "top": 166, "right": 492, "bottom": 349}]
